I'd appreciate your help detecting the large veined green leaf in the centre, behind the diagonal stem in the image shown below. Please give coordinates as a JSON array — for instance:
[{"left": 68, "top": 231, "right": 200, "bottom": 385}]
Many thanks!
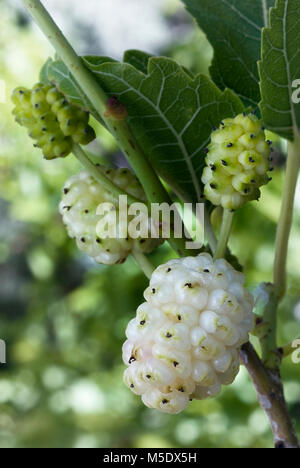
[{"left": 47, "top": 57, "right": 244, "bottom": 200}]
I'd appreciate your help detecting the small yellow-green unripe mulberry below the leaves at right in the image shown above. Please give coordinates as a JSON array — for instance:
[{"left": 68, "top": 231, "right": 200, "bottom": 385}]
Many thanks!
[{"left": 202, "top": 113, "right": 272, "bottom": 210}]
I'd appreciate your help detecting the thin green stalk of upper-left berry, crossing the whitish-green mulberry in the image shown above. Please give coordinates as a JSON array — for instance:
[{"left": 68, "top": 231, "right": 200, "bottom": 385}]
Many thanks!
[{"left": 72, "top": 143, "right": 144, "bottom": 204}]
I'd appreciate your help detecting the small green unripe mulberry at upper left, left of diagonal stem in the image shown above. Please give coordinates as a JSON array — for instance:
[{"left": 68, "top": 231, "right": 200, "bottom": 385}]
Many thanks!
[{"left": 12, "top": 83, "right": 96, "bottom": 159}]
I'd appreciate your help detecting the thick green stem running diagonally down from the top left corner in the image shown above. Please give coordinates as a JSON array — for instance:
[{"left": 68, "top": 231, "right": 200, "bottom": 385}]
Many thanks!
[{"left": 23, "top": 0, "right": 190, "bottom": 256}]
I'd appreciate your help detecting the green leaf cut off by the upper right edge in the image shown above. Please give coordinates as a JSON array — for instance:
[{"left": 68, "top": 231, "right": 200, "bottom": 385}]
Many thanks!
[{"left": 259, "top": 0, "right": 300, "bottom": 140}]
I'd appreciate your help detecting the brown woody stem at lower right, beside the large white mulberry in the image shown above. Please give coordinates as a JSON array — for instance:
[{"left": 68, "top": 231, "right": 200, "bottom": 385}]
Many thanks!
[{"left": 240, "top": 343, "right": 299, "bottom": 448}]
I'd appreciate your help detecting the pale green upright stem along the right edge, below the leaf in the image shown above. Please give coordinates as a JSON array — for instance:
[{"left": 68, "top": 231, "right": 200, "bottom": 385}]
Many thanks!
[{"left": 274, "top": 135, "right": 300, "bottom": 299}]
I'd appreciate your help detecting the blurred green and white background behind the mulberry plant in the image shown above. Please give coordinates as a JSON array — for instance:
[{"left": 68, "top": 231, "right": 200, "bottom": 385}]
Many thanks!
[{"left": 0, "top": 0, "right": 300, "bottom": 448}]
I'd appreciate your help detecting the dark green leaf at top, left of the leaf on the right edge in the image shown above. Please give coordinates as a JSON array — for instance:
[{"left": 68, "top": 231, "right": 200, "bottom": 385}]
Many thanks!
[{"left": 182, "top": 0, "right": 274, "bottom": 110}]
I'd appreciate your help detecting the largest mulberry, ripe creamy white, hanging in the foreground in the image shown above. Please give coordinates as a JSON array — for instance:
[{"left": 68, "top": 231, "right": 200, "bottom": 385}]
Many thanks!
[{"left": 123, "top": 253, "right": 254, "bottom": 414}]
